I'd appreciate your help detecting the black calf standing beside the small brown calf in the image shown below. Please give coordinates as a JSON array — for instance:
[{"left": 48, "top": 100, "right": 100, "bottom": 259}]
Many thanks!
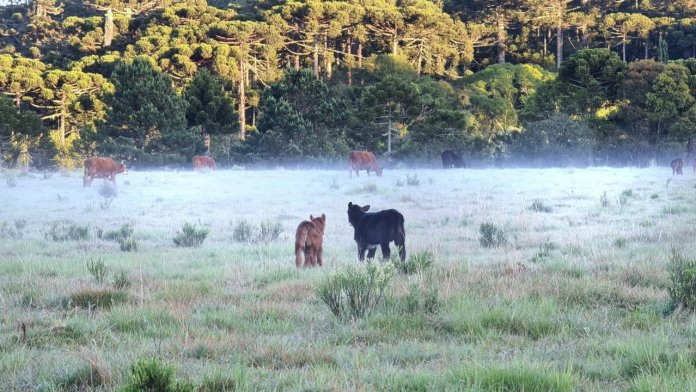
[{"left": 348, "top": 202, "right": 406, "bottom": 261}]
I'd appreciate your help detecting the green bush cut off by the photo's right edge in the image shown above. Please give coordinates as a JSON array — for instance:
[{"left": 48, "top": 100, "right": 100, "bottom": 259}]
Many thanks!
[{"left": 667, "top": 249, "right": 696, "bottom": 310}]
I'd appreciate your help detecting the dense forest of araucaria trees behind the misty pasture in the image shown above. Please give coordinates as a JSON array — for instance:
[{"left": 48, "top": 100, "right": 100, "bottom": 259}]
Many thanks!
[{"left": 0, "top": 0, "right": 696, "bottom": 169}]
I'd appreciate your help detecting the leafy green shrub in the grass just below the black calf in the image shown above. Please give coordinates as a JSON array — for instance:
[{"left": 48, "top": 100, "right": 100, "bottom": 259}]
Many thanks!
[{"left": 316, "top": 262, "right": 394, "bottom": 320}]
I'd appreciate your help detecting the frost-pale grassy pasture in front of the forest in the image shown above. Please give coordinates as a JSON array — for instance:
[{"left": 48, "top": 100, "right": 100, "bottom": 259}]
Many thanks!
[{"left": 0, "top": 168, "right": 696, "bottom": 391}]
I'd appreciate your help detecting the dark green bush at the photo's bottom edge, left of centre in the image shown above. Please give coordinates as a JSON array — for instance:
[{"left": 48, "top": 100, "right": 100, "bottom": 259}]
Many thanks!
[{"left": 120, "top": 359, "right": 194, "bottom": 392}]
